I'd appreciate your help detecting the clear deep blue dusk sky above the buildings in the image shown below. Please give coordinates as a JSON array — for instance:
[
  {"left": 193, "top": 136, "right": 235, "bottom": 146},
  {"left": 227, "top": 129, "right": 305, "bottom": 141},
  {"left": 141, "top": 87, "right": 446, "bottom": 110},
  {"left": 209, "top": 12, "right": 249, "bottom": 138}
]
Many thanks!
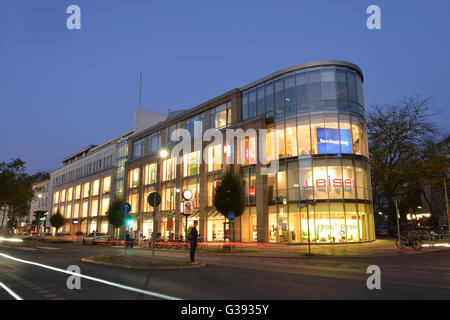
[{"left": 0, "top": 0, "right": 450, "bottom": 173}]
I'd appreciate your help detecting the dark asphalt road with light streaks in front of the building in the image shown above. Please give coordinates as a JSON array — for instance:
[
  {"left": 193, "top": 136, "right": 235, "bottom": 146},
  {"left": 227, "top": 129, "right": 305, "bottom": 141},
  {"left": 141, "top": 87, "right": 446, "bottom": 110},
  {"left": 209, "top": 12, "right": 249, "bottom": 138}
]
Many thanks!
[{"left": 0, "top": 243, "right": 450, "bottom": 300}]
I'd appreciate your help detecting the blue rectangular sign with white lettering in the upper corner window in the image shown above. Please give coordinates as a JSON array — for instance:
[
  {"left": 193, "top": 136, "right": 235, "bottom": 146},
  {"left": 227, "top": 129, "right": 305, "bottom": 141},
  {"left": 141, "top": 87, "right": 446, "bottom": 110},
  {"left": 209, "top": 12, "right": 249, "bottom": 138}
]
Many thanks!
[{"left": 316, "top": 128, "right": 352, "bottom": 154}]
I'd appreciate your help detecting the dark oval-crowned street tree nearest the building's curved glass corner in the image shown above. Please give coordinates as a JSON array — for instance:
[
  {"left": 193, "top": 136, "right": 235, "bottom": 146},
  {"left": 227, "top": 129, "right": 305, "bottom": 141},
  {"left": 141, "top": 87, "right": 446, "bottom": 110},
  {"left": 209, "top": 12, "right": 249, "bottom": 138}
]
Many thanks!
[{"left": 213, "top": 169, "right": 245, "bottom": 249}]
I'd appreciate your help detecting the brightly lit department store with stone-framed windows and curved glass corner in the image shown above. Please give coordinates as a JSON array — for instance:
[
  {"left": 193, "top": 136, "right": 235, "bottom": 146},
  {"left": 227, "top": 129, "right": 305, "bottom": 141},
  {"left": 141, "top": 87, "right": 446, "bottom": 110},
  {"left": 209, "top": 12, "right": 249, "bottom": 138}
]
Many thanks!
[{"left": 123, "top": 60, "right": 375, "bottom": 243}]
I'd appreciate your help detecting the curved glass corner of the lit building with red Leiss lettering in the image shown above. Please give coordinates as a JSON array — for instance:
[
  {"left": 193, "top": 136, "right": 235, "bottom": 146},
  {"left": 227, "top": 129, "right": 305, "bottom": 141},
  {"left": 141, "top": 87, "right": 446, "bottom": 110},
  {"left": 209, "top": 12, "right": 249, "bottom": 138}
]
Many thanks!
[{"left": 242, "top": 66, "right": 375, "bottom": 243}]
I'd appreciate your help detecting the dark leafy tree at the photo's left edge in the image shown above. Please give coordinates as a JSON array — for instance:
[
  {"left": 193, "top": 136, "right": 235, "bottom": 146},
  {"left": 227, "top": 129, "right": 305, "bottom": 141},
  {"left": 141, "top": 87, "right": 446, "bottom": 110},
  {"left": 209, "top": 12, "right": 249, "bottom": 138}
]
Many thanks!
[{"left": 0, "top": 159, "right": 33, "bottom": 229}]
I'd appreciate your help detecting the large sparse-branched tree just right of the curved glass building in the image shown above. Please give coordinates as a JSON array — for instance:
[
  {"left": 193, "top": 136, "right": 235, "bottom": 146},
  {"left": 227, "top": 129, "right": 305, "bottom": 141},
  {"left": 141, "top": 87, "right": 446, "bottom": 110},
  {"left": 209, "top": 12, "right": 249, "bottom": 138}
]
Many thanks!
[{"left": 367, "top": 96, "right": 442, "bottom": 224}]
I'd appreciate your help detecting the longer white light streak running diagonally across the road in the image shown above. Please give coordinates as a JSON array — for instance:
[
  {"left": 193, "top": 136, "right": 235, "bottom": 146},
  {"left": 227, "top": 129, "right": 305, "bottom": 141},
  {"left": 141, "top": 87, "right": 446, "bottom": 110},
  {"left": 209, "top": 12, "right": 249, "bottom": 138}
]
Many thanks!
[{"left": 0, "top": 253, "right": 181, "bottom": 300}]
